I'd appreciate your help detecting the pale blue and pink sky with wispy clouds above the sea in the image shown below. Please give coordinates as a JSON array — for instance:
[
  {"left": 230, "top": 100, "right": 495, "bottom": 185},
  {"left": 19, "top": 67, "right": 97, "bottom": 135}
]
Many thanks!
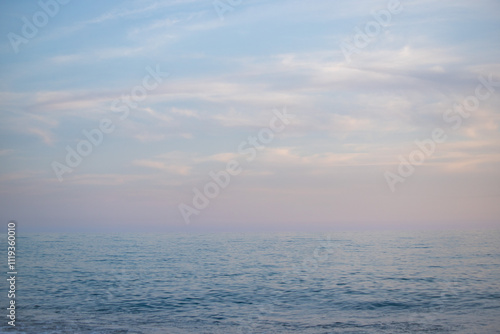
[{"left": 0, "top": 0, "right": 500, "bottom": 232}]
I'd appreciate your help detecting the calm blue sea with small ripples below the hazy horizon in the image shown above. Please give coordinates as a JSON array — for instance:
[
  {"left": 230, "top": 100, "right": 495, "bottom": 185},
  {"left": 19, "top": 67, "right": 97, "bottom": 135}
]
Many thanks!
[{"left": 0, "top": 231, "right": 500, "bottom": 333}]
